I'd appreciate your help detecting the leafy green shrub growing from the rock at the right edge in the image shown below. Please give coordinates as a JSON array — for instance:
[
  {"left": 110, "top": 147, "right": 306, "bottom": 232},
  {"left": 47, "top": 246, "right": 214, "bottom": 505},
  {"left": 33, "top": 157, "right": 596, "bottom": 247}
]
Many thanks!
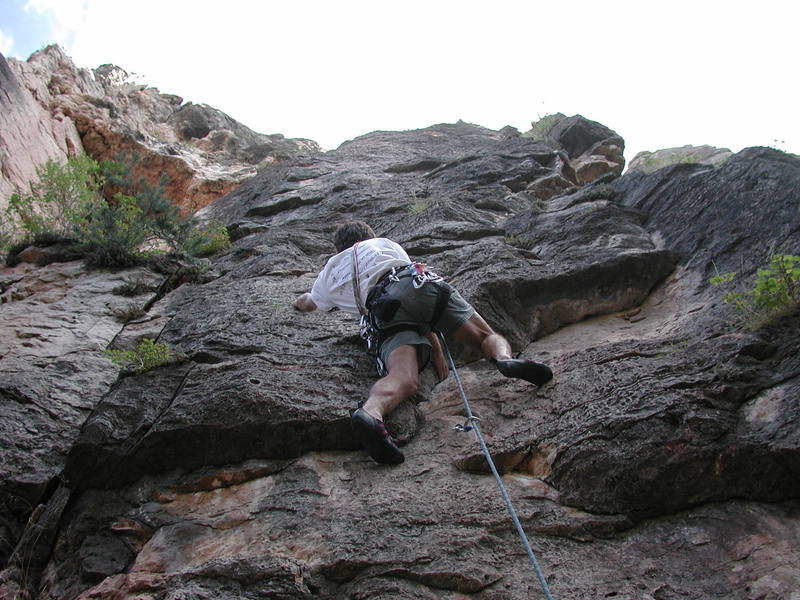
[{"left": 709, "top": 254, "right": 800, "bottom": 327}]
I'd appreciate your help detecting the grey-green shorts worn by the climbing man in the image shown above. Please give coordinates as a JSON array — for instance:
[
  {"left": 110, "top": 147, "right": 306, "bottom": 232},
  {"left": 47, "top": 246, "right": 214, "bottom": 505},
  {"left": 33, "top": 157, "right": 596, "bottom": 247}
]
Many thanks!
[{"left": 378, "top": 277, "right": 475, "bottom": 371}]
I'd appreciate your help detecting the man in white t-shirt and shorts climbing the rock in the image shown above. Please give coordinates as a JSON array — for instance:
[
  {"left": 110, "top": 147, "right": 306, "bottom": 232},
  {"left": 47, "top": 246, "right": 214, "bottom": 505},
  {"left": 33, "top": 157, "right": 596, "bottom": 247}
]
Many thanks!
[{"left": 294, "top": 221, "right": 553, "bottom": 464}]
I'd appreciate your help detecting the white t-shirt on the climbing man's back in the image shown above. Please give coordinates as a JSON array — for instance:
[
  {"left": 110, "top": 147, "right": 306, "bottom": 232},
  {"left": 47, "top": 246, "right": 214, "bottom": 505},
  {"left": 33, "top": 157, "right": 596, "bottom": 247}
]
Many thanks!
[{"left": 311, "top": 238, "right": 411, "bottom": 315}]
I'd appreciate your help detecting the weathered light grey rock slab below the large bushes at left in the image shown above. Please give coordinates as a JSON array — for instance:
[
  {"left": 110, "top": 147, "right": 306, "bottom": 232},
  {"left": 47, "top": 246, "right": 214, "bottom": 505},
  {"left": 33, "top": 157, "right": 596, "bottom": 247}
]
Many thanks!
[{"left": 0, "top": 261, "right": 164, "bottom": 559}]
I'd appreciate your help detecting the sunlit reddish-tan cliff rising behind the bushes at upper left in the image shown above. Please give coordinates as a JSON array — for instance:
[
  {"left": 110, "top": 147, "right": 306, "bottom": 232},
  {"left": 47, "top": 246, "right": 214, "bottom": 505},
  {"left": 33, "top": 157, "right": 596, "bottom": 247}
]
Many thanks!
[{"left": 0, "top": 46, "right": 319, "bottom": 213}]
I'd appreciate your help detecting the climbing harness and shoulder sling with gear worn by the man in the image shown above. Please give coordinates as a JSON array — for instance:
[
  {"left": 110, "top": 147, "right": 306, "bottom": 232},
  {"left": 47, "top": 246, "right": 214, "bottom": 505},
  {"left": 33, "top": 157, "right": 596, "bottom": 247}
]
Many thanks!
[{"left": 352, "top": 242, "right": 453, "bottom": 377}]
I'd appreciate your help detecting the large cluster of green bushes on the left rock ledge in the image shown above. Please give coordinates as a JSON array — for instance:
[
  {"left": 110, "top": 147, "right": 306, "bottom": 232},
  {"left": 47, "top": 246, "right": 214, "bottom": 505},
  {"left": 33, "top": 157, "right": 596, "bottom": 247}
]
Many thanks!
[{"left": 0, "top": 155, "right": 230, "bottom": 267}]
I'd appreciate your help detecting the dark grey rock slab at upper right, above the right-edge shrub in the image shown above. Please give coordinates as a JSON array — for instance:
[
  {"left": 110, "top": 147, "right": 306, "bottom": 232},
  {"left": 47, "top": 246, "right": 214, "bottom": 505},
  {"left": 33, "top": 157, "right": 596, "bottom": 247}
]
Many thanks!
[{"left": 615, "top": 148, "right": 800, "bottom": 278}]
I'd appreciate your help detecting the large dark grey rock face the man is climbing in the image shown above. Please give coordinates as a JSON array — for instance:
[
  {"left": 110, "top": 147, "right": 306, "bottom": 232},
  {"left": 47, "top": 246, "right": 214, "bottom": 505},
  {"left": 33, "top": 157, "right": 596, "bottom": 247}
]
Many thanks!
[{"left": 0, "top": 120, "right": 800, "bottom": 600}]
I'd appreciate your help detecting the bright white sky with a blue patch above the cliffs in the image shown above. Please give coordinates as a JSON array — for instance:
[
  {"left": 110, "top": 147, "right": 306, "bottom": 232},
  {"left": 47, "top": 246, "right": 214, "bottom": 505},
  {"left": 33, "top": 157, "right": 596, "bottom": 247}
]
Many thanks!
[{"left": 0, "top": 0, "right": 800, "bottom": 160}]
